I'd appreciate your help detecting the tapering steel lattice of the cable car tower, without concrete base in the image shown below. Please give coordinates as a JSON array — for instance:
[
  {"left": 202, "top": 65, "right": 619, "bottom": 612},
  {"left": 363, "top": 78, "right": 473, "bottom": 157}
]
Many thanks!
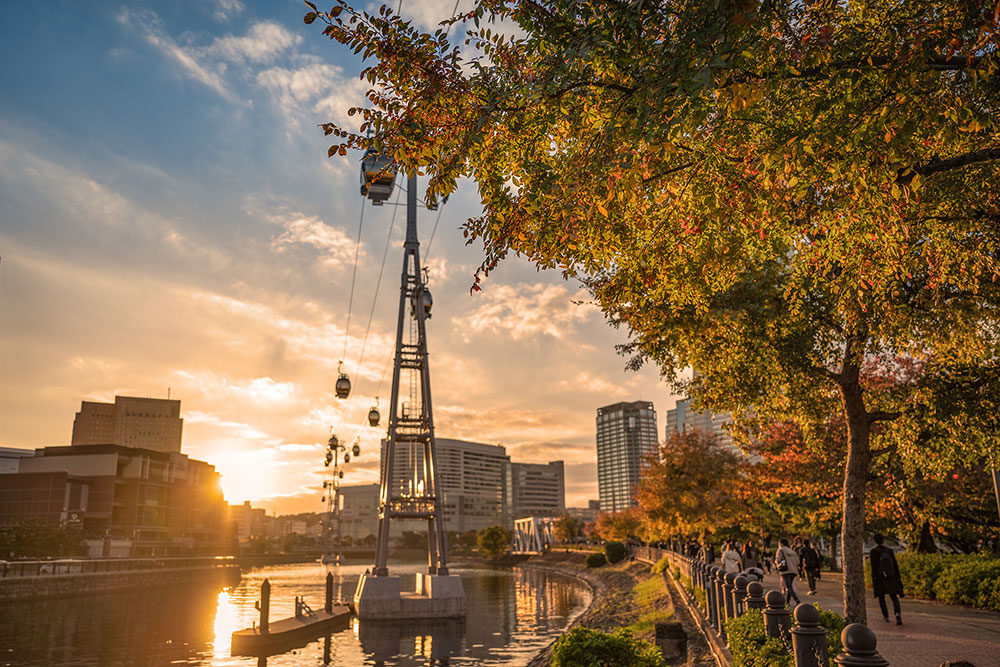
[{"left": 373, "top": 173, "right": 448, "bottom": 577}]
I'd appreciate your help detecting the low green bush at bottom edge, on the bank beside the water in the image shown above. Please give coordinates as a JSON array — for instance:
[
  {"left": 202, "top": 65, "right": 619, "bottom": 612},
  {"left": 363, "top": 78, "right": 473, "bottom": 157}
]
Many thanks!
[{"left": 552, "top": 627, "right": 666, "bottom": 667}]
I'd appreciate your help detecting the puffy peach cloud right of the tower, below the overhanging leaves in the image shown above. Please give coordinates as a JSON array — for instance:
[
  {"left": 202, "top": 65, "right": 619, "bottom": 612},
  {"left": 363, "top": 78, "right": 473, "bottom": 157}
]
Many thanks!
[{"left": 455, "top": 284, "right": 597, "bottom": 341}]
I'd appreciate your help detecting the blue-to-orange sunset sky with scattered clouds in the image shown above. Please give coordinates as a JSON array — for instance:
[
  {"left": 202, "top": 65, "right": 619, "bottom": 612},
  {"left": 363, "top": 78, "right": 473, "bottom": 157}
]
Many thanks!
[{"left": 0, "top": 0, "right": 677, "bottom": 514}]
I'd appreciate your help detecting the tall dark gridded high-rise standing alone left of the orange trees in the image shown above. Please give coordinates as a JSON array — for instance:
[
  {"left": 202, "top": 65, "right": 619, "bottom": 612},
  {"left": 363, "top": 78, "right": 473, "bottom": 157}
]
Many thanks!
[{"left": 597, "top": 401, "right": 657, "bottom": 512}]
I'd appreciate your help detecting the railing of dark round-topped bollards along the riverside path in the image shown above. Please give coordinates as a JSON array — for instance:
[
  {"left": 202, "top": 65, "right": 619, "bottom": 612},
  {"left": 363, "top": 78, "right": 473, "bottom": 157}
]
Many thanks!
[{"left": 632, "top": 547, "right": 889, "bottom": 667}]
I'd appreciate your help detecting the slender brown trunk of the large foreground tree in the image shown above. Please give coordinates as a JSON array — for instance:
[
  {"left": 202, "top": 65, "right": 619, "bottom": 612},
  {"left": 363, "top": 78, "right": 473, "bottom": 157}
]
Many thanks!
[{"left": 839, "top": 368, "right": 871, "bottom": 623}]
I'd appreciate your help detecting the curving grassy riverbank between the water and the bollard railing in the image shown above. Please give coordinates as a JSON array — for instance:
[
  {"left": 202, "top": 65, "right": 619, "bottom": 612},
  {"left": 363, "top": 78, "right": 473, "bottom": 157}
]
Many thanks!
[{"left": 518, "top": 551, "right": 715, "bottom": 667}]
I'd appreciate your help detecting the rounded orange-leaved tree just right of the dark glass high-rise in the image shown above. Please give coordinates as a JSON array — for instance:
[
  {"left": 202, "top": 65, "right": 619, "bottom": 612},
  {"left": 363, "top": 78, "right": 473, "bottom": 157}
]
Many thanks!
[{"left": 635, "top": 431, "right": 746, "bottom": 539}]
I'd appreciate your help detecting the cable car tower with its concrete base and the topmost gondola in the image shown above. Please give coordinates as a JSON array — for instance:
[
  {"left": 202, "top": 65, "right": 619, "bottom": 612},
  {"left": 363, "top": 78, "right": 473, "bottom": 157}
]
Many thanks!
[{"left": 354, "top": 150, "right": 465, "bottom": 619}]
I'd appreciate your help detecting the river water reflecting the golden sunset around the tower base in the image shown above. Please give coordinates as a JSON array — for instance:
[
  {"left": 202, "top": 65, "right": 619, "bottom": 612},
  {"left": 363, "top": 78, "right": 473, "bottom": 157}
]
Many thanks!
[{"left": 0, "top": 564, "right": 590, "bottom": 667}]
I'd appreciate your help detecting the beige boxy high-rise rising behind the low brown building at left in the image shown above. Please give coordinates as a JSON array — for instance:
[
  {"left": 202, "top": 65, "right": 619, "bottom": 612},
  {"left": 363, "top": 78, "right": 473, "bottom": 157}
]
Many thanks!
[{"left": 70, "top": 396, "right": 184, "bottom": 452}]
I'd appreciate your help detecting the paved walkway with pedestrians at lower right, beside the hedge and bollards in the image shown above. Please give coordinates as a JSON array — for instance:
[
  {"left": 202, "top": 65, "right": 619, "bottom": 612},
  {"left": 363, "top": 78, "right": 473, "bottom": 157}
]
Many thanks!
[{"left": 764, "top": 572, "right": 1000, "bottom": 667}]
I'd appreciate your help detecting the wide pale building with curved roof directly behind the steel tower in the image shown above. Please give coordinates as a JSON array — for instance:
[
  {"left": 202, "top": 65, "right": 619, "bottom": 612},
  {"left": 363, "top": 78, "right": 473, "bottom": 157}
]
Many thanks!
[{"left": 382, "top": 438, "right": 510, "bottom": 536}]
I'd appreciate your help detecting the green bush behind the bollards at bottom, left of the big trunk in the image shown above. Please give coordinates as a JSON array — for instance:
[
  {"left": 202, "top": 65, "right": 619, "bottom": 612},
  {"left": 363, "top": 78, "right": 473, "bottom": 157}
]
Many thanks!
[{"left": 726, "top": 605, "right": 845, "bottom": 667}]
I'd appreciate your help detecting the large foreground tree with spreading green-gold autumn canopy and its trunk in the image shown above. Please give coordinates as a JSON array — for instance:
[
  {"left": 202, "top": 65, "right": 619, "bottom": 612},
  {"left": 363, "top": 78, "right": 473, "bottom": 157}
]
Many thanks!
[{"left": 306, "top": 0, "right": 1000, "bottom": 622}]
